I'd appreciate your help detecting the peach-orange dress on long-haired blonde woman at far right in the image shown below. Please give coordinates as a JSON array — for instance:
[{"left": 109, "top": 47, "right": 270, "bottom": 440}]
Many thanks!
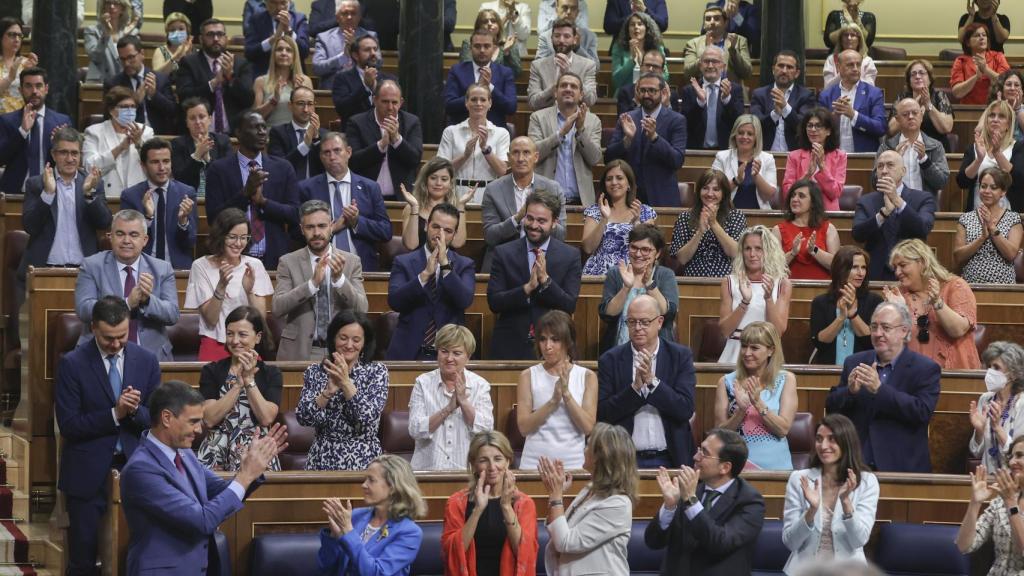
[{"left": 904, "top": 276, "right": 981, "bottom": 370}]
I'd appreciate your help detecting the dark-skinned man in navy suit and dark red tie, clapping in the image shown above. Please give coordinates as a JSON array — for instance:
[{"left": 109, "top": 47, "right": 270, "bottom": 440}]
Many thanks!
[{"left": 206, "top": 111, "right": 299, "bottom": 270}]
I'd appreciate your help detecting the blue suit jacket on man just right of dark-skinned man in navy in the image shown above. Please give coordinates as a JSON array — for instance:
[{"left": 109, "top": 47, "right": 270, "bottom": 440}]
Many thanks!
[{"left": 299, "top": 172, "right": 392, "bottom": 272}]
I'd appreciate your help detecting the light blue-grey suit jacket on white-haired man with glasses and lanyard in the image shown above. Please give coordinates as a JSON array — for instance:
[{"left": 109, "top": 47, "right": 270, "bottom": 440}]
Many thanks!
[{"left": 75, "top": 250, "right": 180, "bottom": 362}]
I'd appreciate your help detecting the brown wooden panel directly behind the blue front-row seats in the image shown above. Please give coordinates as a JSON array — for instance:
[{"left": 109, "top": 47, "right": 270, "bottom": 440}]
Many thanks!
[{"left": 100, "top": 470, "right": 971, "bottom": 574}]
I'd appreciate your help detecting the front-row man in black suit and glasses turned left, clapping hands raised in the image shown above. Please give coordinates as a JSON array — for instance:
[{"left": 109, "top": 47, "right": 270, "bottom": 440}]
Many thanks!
[{"left": 644, "top": 428, "right": 765, "bottom": 576}]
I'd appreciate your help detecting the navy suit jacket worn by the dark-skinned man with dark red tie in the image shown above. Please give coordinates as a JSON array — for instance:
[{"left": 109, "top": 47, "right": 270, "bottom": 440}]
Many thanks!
[{"left": 206, "top": 154, "right": 299, "bottom": 270}]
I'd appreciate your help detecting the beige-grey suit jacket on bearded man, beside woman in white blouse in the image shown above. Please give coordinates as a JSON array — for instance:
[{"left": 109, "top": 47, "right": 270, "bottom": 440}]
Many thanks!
[{"left": 271, "top": 248, "right": 369, "bottom": 361}]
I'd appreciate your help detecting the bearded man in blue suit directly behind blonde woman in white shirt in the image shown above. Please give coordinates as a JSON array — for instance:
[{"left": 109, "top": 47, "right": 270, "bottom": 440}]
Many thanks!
[{"left": 444, "top": 32, "right": 516, "bottom": 126}]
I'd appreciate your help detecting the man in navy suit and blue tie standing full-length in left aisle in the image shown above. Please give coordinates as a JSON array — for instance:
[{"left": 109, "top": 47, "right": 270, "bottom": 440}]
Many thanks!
[{"left": 53, "top": 295, "right": 160, "bottom": 575}]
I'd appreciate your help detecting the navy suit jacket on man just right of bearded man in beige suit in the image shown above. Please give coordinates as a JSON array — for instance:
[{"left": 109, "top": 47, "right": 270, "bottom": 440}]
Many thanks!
[{"left": 385, "top": 246, "right": 476, "bottom": 360}]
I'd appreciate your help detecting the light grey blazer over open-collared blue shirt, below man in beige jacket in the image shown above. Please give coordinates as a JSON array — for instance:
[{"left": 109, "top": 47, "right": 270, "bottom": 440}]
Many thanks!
[{"left": 528, "top": 106, "right": 602, "bottom": 207}]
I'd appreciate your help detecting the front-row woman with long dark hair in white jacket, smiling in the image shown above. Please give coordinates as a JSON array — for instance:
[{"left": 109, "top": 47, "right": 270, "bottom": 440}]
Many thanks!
[{"left": 782, "top": 414, "right": 879, "bottom": 574}]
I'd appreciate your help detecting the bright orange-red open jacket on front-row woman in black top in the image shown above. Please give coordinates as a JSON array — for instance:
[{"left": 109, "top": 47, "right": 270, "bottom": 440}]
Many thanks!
[{"left": 441, "top": 489, "right": 538, "bottom": 576}]
